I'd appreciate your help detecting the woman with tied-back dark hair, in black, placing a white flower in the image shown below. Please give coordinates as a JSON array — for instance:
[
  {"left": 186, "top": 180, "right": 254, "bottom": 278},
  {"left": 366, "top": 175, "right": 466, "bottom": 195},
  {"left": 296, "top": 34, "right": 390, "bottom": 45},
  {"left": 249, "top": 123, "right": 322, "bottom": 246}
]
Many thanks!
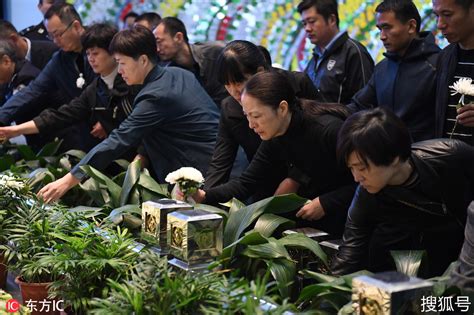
[{"left": 193, "top": 72, "right": 354, "bottom": 234}]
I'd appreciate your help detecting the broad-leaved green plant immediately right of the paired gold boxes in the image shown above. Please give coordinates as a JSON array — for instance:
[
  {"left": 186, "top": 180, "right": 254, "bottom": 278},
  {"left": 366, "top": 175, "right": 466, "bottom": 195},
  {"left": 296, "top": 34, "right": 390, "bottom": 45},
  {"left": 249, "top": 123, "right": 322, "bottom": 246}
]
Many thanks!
[{"left": 215, "top": 194, "right": 327, "bottom": 299}]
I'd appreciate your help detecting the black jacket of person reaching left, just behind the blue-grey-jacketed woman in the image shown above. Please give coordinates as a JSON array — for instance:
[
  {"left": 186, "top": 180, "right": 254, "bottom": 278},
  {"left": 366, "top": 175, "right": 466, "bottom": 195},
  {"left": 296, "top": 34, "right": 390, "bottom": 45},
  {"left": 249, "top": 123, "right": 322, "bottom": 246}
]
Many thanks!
[{"left": 33, "top": 74, "right": 139, "bottom": 138}]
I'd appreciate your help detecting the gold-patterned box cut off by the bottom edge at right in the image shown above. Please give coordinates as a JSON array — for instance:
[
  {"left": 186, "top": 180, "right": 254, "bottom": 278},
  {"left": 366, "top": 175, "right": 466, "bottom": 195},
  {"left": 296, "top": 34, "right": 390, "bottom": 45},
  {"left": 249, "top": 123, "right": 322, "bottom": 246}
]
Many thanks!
[{"left": 352, "top": 271, "right": 434, "bottom": 315}]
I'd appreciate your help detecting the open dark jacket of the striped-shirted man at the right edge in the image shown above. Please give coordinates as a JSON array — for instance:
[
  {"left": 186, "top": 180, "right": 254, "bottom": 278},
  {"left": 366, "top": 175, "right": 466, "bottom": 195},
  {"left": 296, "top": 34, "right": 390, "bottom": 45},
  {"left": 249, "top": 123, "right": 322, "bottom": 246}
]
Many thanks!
[{"left": 435, "top": 43, "right": 474, "bottom": 145}]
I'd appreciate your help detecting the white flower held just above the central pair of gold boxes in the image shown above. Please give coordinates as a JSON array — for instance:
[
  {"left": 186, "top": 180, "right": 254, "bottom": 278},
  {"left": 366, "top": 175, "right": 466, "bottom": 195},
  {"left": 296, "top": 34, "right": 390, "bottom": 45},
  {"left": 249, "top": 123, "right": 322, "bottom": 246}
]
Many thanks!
[{"left": 165, "top": 167, "right": 204, "bottom": 201}]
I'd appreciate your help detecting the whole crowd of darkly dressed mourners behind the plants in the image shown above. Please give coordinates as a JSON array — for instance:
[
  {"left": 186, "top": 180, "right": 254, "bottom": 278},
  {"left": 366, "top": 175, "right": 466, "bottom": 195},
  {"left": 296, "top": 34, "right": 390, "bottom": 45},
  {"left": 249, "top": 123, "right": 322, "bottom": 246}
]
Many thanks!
[{"left": 0, "top": 0, "right": 474, "bottom": 290}]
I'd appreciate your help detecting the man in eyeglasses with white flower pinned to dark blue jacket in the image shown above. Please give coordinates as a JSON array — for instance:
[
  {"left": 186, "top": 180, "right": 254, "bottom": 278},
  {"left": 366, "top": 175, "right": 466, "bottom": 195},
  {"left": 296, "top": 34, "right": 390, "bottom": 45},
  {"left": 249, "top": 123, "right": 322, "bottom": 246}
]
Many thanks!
[{"left": 0, "top": 4, "right": 96, "bottom": 151}]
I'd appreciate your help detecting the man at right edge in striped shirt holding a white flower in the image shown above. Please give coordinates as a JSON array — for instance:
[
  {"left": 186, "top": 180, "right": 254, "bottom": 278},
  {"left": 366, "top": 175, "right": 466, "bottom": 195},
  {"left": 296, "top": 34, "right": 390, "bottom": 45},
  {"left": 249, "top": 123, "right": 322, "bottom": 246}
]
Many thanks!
[{"left": 433, "top": 0, "right": 474, "bottom": 145}]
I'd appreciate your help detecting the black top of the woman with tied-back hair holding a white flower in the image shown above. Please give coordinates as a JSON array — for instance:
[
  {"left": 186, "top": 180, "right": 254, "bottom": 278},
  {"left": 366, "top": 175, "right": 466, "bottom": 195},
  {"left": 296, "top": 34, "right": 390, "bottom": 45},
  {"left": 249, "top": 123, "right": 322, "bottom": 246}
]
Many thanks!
[{"left": 206, "top": 110, "right": 354, "bottom": 235}]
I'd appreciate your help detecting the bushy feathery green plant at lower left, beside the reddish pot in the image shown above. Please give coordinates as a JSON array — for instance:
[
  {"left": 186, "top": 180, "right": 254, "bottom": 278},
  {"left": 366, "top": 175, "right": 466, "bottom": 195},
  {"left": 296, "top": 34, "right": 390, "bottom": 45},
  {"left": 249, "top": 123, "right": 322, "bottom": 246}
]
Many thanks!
[{"left": 38, "top": 224, "right": 138, "bottom": 314}]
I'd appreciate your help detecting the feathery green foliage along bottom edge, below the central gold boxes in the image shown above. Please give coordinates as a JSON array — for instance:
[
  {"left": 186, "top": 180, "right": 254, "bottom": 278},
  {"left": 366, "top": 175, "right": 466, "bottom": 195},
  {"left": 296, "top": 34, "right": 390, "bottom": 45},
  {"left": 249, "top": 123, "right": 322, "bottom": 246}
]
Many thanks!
[{"left": 90, "top": 251, "right": 295, "bottom": 315}]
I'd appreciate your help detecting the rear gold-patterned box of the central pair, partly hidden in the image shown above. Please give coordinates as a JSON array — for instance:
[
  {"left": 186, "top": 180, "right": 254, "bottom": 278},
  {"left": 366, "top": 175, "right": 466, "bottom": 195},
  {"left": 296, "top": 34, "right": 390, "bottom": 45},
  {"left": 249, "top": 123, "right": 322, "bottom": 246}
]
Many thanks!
[{"left": 142, "top": 199, "right": 193, "bottom": 253}]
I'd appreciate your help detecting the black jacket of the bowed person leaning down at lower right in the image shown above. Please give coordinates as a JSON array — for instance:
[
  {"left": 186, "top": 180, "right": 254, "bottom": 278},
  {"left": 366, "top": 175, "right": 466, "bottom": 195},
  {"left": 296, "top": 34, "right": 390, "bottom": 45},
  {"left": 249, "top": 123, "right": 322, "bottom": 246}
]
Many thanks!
[{"left": 331, "top": 139, "right": 474, "bottom": 275}]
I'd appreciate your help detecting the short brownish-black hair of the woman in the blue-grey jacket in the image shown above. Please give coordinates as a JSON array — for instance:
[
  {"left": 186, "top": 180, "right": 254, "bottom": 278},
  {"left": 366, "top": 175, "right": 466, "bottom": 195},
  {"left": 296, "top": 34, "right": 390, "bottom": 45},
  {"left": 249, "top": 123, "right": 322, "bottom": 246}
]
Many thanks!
[{"left": 109, "top": 25, "right": 158, "bottom": 64}]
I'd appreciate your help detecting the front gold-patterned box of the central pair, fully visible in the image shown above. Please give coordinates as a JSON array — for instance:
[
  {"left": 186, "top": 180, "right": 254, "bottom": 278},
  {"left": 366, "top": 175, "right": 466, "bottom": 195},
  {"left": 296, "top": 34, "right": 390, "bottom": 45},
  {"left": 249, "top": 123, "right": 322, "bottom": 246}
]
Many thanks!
[{"left": 167, "top": 209, "right": 223, "bottom": 266}]
